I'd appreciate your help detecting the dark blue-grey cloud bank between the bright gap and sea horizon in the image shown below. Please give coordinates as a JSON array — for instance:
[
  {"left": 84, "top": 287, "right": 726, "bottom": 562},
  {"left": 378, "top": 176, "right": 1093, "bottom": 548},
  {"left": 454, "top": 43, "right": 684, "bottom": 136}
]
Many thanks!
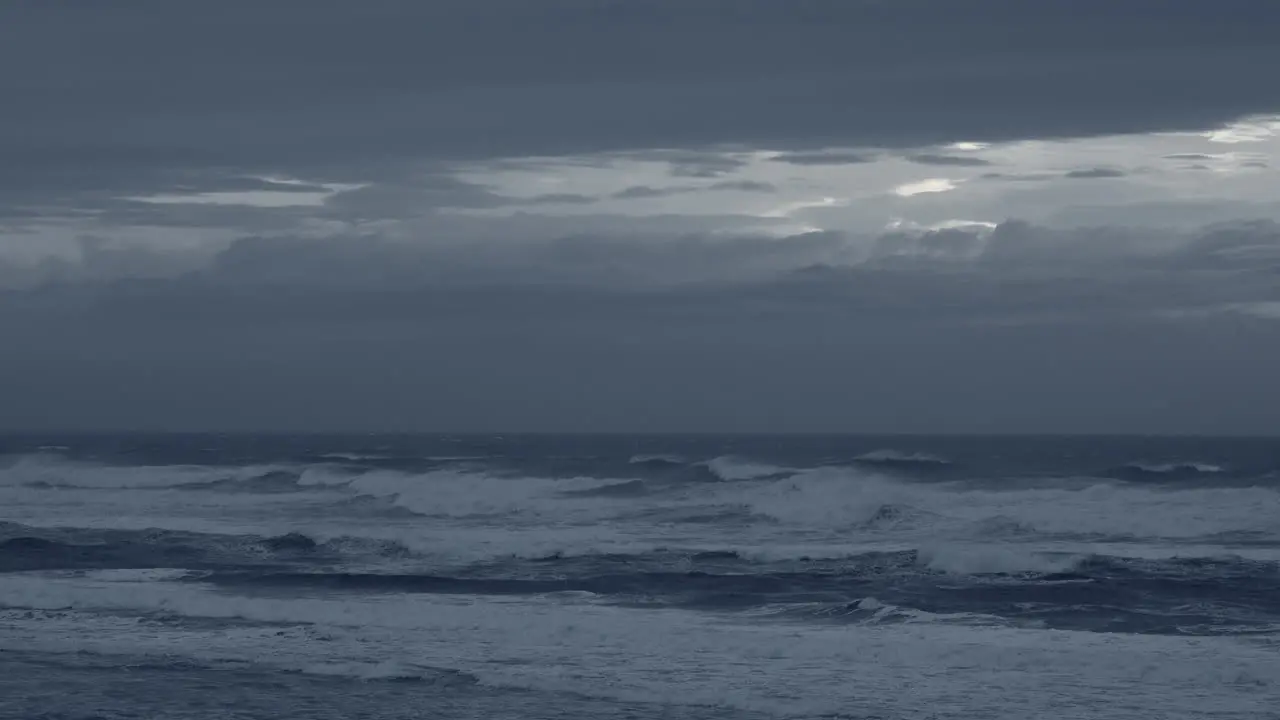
[{"left": 0, "top": 222, "right": 1280, "bottom": 433}]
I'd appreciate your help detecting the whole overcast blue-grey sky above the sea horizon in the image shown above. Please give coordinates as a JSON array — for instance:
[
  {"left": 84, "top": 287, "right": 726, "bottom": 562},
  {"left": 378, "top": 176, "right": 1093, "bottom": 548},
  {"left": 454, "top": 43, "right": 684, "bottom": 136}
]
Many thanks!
[{"left": 0, "top": 0, "right": 1280, "bottom": 434}]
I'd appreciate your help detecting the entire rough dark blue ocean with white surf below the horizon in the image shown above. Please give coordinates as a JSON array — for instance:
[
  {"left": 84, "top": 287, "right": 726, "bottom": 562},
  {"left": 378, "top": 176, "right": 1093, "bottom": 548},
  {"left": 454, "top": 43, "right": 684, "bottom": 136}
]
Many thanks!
[{"left": 0, "top": 434, "right": 1280, "bottom": 720}]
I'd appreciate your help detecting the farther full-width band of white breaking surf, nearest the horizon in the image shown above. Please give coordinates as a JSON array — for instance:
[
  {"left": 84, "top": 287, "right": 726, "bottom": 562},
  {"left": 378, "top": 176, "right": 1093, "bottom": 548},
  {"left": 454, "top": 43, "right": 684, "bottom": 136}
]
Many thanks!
[{"left": 0, "top": 456, "right": 1280, "bottom": 547}]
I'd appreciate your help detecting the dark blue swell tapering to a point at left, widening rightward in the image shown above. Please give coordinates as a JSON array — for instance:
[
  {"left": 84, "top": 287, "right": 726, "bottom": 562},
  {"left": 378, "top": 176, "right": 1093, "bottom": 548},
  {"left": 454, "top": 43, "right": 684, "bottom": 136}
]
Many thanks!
[{"left": 167, "top": 543, "right": 1280, "bottom": 634}]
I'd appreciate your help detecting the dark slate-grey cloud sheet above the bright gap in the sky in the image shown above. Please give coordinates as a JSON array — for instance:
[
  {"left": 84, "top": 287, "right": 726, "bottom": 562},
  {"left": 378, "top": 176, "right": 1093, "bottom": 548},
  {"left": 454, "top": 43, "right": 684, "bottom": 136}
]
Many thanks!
[{"left": 0, "top": 0, "right": 1280, "bottom": 210}]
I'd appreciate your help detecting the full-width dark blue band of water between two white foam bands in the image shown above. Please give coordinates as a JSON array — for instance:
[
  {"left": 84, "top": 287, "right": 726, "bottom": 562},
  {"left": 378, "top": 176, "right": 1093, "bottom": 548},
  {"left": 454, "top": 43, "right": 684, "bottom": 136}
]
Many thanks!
[{"left": 0, "top": 527, "right": 1280, "bottom": 634}]
